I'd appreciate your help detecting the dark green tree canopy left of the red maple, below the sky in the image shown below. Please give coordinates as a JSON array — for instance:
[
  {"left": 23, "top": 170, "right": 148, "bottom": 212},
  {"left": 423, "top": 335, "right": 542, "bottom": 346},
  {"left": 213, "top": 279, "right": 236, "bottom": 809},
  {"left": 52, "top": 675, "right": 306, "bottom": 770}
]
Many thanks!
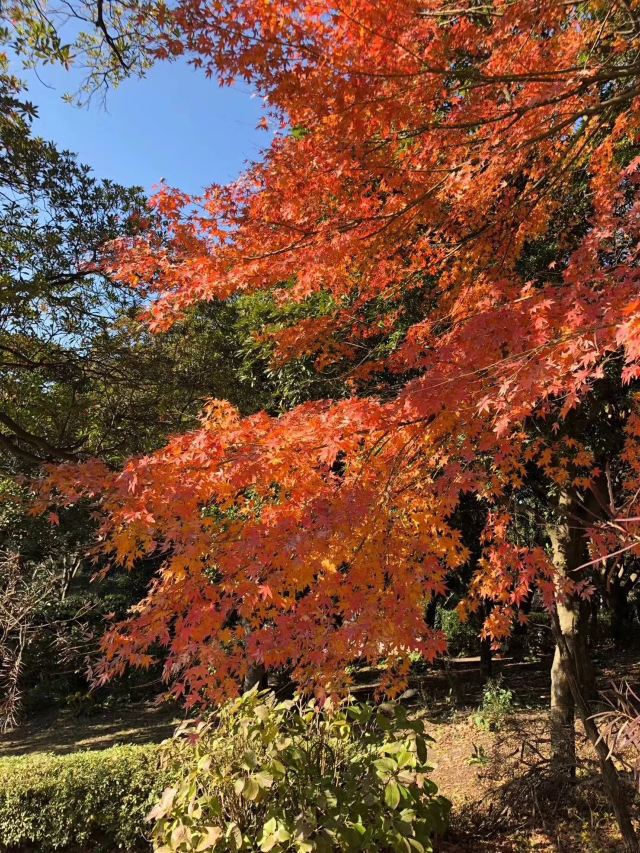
[{"left": 0, "top": 51, "right": 348, "bottom": 465}]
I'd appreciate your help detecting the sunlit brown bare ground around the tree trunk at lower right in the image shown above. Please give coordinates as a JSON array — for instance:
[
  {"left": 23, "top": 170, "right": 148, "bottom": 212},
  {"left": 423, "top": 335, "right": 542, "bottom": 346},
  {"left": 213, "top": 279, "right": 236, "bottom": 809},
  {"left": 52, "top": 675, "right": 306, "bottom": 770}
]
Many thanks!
[{"left": 427, "top": 654, "right": 640, "bottom": 853}]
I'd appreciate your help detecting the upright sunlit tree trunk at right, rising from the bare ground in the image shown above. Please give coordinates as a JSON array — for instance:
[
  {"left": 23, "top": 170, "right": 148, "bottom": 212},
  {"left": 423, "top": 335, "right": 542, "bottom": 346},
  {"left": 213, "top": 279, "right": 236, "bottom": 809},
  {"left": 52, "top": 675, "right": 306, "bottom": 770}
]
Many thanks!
[{"left": 549, "top": 493, "right": 593, "bottom": 776}]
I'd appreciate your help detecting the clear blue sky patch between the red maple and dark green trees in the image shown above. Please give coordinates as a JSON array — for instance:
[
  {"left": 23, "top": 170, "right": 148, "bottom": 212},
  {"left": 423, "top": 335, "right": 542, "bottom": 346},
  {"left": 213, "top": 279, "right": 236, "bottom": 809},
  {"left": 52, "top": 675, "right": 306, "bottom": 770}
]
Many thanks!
[{"left": 14, "top": 57, "right": 270, "bottom": 192}]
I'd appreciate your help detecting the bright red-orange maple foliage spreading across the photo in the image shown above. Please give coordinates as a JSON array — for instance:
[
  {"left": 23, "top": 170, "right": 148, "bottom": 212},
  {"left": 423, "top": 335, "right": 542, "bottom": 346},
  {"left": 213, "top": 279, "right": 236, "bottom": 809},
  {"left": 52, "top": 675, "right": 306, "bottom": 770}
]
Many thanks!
[{"left": 37, "top": 0, "right": 640, "bottom": 698}]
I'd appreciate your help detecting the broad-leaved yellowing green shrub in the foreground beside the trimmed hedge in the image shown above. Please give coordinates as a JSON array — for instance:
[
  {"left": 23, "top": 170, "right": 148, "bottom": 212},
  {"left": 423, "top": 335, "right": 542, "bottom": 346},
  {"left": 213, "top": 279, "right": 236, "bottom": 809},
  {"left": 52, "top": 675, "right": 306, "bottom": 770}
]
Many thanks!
[{"left": 150, "top": 689, "right": 449, "bottom": 853}]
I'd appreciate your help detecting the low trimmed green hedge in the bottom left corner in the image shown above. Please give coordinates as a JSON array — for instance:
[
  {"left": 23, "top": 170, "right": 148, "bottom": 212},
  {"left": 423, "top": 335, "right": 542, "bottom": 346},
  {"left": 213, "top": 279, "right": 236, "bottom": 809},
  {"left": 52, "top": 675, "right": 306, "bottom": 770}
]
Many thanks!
[{"left": 0, "top": 744, "right": 166, "bottom": 853}]
